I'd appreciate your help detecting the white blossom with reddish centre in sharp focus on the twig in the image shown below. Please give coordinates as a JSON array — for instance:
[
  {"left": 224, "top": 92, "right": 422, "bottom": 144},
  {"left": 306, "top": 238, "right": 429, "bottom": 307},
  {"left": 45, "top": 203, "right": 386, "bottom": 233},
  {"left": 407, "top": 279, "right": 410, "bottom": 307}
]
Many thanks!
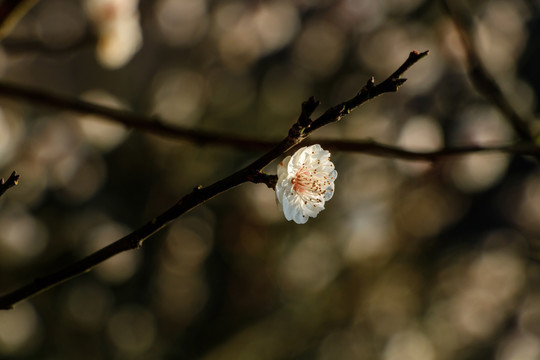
[{"left": 276, "top": 145, "right": 337, "bottom": 224}]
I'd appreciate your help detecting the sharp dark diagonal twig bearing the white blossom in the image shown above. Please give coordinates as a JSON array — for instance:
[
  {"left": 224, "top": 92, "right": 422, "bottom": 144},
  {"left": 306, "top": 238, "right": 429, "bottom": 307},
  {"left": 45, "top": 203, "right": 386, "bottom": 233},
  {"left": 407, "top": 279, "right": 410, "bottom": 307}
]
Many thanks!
[{"left": 0, "top": 52, "right": 430, "bottom": 309}]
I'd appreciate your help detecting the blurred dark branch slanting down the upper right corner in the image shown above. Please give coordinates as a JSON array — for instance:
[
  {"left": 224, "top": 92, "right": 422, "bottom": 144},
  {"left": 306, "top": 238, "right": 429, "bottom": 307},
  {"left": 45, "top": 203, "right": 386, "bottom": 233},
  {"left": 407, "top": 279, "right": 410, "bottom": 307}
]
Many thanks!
[{"left": 441, "top": 0, "right": 534, "bottom": 141}]
